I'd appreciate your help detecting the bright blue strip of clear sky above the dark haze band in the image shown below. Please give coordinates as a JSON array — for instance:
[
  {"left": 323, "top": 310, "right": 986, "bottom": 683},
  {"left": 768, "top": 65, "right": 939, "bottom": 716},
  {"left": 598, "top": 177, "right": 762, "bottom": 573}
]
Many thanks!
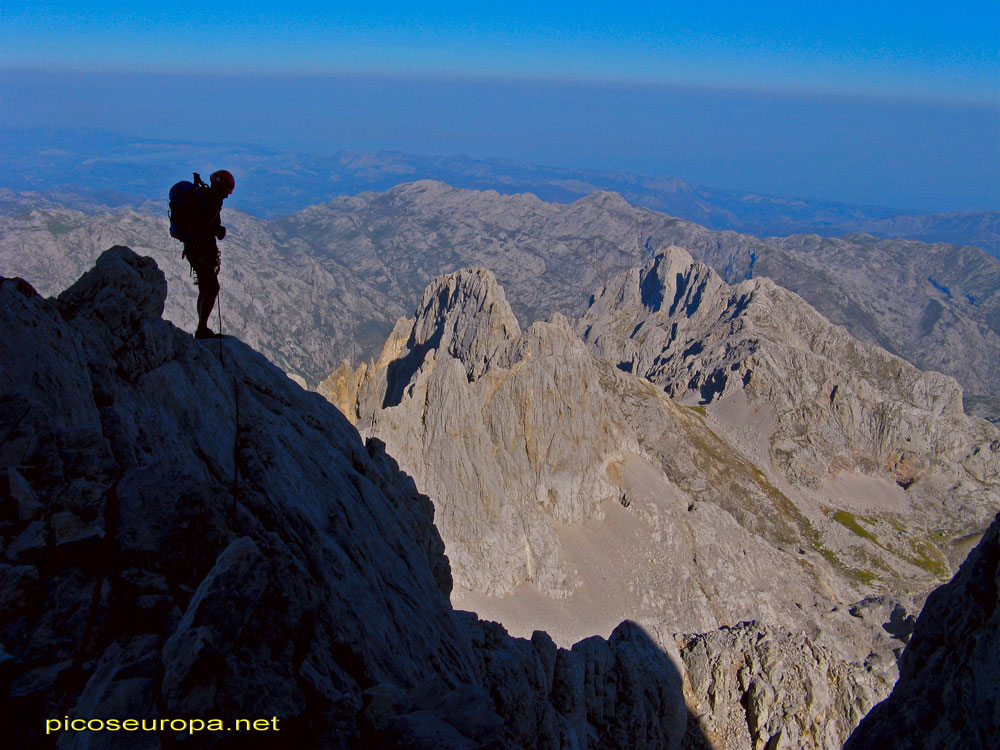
[{"left": 0, "top": 0, "right": 1000, "bottom": 101}]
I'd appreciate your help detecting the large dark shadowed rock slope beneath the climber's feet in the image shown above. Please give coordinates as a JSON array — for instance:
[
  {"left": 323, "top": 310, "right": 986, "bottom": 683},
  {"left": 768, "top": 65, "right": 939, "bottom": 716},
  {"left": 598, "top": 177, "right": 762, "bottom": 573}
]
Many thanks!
[{"left": 0, "top": 247, "right": 710, "bottom": 748}]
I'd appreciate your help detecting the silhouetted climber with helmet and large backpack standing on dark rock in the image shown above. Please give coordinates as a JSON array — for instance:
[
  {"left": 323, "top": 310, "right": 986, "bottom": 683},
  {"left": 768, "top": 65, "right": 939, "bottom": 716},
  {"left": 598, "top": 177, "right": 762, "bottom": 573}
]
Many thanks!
[{"left": 170, "top": 169, "right": 236, "bottom": 339}]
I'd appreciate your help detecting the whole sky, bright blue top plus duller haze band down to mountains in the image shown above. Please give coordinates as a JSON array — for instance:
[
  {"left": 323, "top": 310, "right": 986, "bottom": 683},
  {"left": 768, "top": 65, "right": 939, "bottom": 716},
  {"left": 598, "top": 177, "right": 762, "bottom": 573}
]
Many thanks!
[{"left": 0, "top": 0, "right": 1000, "bottom": 210}]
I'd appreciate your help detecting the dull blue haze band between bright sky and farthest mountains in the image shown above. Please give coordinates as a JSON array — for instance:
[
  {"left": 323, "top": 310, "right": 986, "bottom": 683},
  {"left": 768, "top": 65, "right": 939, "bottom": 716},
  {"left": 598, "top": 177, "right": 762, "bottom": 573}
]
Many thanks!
[{"left": 0, "top": 70, "right": 1000, "bottom": 211}]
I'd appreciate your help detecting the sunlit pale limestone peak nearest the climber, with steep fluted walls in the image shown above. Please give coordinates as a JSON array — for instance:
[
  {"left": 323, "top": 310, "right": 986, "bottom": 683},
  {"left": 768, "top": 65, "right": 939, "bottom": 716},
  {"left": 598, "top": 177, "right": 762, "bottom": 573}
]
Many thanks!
[{"left": 342, "top": 269, "right": 629, "bottom": 594}]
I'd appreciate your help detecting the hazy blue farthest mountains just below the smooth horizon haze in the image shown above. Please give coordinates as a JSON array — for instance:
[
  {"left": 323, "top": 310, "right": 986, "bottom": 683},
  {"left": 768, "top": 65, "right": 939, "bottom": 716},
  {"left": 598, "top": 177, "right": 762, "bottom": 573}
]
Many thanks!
[{"left": 0, "top": 128, "right": 1000, "bottom": 257}]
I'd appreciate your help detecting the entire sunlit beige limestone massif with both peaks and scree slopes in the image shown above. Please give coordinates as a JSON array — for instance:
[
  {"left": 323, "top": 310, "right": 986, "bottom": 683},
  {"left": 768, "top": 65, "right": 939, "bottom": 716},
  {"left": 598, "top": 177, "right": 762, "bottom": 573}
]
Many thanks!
[{"left": 326, "top": 262, "right": 995, "bottom": 748}]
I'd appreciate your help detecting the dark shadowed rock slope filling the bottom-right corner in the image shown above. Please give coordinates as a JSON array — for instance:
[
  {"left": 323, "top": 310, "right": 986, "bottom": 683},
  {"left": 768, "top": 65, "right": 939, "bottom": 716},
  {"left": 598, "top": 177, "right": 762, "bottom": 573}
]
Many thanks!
[{"left": 845, "top": 515, "right": 1000, "bottom": 750}]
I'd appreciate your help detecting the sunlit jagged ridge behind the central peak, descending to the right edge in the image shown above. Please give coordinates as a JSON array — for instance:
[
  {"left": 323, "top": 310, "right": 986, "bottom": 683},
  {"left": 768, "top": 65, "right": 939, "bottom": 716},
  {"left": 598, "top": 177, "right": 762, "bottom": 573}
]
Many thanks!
[{"left": 578, "top": 247, "right": 1000, "bottom": 536}]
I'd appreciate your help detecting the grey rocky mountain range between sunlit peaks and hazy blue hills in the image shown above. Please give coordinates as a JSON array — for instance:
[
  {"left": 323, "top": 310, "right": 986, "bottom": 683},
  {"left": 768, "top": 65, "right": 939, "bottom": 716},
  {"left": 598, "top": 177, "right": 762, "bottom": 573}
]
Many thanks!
[{"left": 0, "top": 181, "right": 1000, "bottom": 417}]
